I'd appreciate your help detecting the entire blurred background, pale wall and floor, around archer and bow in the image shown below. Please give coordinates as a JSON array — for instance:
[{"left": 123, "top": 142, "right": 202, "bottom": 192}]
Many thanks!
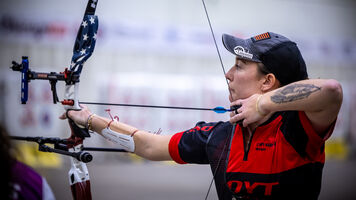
[{"left": 0, "top": 0, "right": 356, "bottom": 199}]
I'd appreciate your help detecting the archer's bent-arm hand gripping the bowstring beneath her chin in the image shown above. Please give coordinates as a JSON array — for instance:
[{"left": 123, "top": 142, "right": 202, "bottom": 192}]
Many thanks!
[{"left": 230, "top": 94, "right": 268, "bottom": 127}]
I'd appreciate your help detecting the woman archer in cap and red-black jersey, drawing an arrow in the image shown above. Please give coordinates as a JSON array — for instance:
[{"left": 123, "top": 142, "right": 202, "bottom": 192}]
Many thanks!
[{"left": 61, "top": 32, "right": 343, "bottom": 199}]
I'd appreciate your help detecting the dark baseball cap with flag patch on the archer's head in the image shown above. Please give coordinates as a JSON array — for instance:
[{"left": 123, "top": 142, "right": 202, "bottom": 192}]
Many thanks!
[{"left": 222, "top": 32, "right": 308, "bottom": 85}]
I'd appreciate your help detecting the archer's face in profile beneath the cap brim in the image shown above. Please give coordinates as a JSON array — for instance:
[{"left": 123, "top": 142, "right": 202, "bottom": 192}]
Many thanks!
[{"left": 226, "top": 58, "right": 263, "bottom": 102}]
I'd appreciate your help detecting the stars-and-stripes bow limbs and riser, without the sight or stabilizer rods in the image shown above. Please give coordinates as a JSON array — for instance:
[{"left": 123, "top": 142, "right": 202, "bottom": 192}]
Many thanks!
[{"left": 62, "top": 0, "right": 98, "bottom": 200}]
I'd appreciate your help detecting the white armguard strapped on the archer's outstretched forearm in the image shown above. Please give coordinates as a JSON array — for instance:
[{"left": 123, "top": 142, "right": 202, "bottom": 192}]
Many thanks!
[{"left": 101, "top": 127, "right": 135, "bottom": 152}]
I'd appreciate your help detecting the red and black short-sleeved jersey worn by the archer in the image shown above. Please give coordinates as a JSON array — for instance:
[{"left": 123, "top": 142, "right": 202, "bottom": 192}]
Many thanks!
[{"left": 169, "top": 111, "right": 335, "bottom": 199}]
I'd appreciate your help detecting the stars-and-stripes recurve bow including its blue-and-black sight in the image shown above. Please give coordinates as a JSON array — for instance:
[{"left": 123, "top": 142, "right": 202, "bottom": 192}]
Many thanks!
[{"left": 12, "top": 0, "right": 98, "bottom": 200}]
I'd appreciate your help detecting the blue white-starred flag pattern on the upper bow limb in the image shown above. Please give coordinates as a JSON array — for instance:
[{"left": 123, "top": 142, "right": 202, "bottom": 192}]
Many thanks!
[{"left": 70, "top": 15, "right": 99, "bottom": 73}]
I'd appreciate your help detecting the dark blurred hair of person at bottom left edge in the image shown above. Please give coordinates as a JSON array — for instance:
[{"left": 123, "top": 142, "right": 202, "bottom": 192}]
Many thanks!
[{"left": 0, "top": 124, "right": 14, "bottom": 199}]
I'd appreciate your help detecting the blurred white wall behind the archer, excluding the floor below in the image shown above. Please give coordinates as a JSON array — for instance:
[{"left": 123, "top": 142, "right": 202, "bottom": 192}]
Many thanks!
[{"left": 0, "top": 0, "right": 356, "bottom": 146}]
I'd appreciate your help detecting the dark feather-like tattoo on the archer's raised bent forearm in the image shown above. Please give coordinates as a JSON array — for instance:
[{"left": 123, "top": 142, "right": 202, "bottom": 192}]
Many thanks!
[{"left": 271, "top": 84, "right": 321, "bottom": 103}]
